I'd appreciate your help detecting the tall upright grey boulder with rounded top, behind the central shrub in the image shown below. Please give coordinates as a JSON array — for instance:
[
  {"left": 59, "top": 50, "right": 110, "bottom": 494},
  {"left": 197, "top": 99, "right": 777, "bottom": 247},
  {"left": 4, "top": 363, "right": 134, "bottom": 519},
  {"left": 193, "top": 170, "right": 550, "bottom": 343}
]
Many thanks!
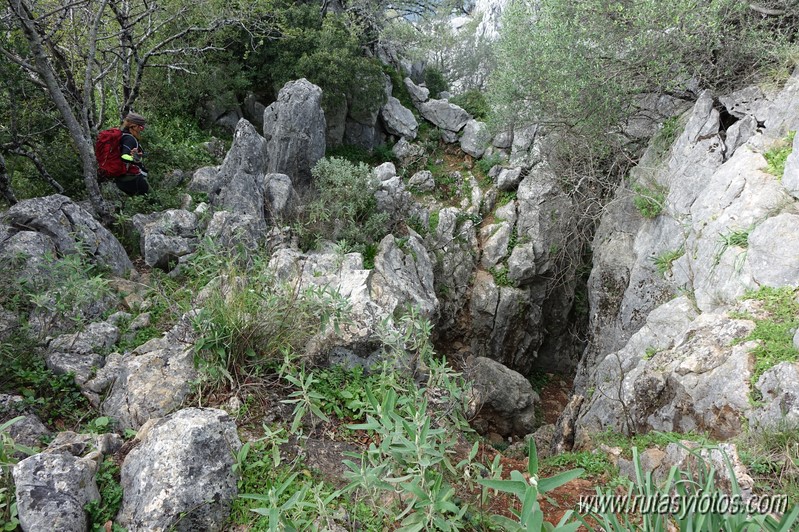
[{"left": 264, "top": 78, "right": 327, "bottom": 187}]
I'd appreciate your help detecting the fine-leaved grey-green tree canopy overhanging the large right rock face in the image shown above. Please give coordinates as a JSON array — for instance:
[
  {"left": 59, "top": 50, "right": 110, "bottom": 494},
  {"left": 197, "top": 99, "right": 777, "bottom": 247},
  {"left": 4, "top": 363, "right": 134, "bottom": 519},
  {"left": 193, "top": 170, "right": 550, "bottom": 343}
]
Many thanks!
[{"left": 489, "top": 0, "right": 796, "bottom": 144}]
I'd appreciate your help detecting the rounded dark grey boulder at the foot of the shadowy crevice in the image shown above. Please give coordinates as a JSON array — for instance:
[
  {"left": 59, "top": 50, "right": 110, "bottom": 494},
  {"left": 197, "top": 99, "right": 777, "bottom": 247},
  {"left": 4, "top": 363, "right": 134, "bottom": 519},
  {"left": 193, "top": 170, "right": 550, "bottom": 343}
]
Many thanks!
[{"left": 464, "top": 357, "right": 539, "bottom": 436}]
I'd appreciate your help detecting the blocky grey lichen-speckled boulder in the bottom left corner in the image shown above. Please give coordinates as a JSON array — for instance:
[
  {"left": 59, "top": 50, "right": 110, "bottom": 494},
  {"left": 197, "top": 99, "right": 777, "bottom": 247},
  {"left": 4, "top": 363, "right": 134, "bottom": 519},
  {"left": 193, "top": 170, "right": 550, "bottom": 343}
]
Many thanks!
[{"left": 12, "top": 453, "right": 100, "bottom": 532}]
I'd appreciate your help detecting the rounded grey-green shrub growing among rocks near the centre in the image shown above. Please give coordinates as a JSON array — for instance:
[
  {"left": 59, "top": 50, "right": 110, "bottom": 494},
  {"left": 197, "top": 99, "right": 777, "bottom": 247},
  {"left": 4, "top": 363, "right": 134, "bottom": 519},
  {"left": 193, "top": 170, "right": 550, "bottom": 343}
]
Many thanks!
[{"left": 295, "top": 158, "right": 390, "bottom": 251}]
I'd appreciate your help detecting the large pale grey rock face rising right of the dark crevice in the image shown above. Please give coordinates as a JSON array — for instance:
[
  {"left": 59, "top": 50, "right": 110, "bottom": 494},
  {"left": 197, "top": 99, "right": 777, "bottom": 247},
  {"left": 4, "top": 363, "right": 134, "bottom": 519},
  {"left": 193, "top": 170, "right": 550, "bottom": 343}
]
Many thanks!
[{"left": 575, "top": 71, "right": 799, "bottom": 444}]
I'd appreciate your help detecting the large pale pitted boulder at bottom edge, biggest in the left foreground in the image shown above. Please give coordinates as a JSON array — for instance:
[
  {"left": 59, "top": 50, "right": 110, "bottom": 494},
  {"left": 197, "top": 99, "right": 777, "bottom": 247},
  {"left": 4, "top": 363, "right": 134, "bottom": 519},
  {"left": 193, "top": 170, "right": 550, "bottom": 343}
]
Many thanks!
[{"left": 117, "top": 408, "right": 241, "bottom": 532}]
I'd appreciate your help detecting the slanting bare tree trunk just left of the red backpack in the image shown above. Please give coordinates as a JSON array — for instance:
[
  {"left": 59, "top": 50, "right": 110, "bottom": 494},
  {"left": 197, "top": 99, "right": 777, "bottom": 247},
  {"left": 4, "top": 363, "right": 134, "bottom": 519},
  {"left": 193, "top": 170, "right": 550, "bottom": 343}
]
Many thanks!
[{"left": 9, "top": 0, "right": 111, "bottom": 223}]
